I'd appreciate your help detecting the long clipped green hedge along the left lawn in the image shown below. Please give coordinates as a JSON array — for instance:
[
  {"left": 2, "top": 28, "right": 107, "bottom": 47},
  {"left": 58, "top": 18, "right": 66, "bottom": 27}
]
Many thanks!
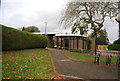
[{"left": 0, "top": 25, "right": 48, "bottom": 51}]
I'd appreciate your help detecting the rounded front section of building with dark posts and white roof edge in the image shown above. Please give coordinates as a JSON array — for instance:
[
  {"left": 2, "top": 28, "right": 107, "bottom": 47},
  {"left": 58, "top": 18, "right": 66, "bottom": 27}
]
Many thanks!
[{"left": 55, "top": 34, "right": 86, "bottom": 50}]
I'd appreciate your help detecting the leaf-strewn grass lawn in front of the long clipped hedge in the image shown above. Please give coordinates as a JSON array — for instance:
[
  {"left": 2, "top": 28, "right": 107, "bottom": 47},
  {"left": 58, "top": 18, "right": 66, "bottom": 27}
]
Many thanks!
[{"left": 2, "top": 49, "right": 56, "bottom": 79}]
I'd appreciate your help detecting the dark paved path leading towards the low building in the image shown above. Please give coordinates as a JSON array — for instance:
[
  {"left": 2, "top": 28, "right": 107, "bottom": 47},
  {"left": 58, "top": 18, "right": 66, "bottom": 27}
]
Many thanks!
[{"left": 49, "top": 48, "right": 118, "bottom": 79}]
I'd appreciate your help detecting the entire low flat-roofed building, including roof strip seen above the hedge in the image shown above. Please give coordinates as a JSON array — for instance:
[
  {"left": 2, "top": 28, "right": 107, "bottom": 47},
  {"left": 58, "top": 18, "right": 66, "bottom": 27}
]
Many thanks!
[{"left": 34, "top": 32, "right": 87, "bottom": 50}]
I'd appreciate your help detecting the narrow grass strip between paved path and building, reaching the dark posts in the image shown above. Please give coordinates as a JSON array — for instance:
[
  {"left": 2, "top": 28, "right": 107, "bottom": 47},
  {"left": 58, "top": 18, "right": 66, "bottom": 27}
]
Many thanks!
[{"left": 62, "top": 51, "right": 117, "bottom": 64}]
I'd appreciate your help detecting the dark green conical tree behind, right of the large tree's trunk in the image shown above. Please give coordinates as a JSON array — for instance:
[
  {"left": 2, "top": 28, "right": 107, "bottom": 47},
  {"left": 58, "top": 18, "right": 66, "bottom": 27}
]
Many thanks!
[{"left": 96, "top": 29, "right": 109, "bottom": 45}]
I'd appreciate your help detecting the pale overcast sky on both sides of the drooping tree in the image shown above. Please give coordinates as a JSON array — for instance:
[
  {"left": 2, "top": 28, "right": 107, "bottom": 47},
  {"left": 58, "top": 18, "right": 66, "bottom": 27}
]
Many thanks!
[{"left": 0, "top": 0, "right": 118, "bottom": 43}]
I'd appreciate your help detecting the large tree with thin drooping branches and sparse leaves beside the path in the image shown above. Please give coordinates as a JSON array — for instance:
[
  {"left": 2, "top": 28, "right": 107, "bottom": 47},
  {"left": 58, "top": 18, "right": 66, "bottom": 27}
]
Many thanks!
[{"left": 61, "top": 2, "right": 118, "bottom": 54}]
